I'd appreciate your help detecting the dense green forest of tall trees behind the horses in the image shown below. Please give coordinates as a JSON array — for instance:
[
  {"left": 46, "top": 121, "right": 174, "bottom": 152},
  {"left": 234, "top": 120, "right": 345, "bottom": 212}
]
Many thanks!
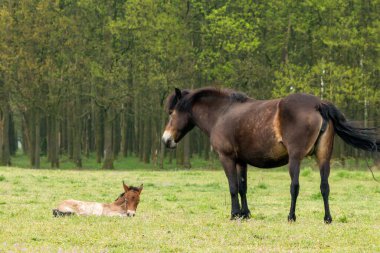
[{"left": 0, "top": 0, "right": 380, "bottom": 169}]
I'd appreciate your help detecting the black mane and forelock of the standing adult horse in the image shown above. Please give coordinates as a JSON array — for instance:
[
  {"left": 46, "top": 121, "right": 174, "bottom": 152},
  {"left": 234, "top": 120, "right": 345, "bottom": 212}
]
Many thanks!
[{"left": 166, "top": 87, "right": 249, "bottom": 112}]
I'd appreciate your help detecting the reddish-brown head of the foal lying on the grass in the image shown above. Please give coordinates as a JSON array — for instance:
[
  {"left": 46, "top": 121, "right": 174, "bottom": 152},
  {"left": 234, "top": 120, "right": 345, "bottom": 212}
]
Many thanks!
[{"left": 115, "top": 181, "right": 143, "bottom": 217}]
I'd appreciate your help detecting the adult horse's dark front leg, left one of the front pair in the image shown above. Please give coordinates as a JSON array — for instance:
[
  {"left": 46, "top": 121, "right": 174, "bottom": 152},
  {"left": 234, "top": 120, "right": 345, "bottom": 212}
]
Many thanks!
[{"left": 219, "top": 155, "right": 240, "bottom": 220}]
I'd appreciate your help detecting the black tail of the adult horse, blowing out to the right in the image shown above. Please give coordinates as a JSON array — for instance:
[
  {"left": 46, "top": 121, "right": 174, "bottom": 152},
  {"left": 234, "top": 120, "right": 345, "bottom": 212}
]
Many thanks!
[{"left": 318, "top": 102, "right": 380, "bottom": 152}]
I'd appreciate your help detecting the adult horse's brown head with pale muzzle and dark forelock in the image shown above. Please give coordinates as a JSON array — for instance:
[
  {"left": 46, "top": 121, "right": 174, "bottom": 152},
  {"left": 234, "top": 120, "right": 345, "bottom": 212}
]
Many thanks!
[{"left": 162, "top": 88, "right": 194, "bottom": 148}]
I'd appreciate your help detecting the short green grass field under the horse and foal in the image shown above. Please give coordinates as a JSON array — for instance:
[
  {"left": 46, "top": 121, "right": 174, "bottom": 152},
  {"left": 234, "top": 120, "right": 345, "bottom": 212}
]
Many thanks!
[{"left": 0, "top": 167, "right": 380, "bottom": 252}]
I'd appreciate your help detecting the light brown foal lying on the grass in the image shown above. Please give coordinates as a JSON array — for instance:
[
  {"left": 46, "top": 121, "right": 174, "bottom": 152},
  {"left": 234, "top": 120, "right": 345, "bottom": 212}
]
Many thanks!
[{"left": 53, "top": 181, "right": 143, "bottom": 217}]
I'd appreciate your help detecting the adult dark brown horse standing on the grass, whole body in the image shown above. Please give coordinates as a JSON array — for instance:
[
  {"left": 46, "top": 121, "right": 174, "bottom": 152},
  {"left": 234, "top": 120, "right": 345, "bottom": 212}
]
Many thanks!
[{"left": 162, "top": 88, "right": 380, "bottom": 223}]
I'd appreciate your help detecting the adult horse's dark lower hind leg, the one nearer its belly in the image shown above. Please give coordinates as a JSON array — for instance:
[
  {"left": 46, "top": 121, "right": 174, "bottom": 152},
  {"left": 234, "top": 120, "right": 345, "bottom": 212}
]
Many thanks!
[{"left": 288, "top": 158, "right": 301, "bottom": 222}]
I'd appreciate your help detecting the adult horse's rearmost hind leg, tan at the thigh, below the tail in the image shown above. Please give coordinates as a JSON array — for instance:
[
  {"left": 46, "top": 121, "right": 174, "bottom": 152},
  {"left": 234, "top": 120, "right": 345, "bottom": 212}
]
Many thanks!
[{"left": 316, "top": 123, "right": 334, "bottom": 224}]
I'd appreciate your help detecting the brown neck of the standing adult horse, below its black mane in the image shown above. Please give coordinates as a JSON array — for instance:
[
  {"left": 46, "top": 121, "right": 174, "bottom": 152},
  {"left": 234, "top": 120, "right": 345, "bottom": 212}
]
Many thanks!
[{"left": 192, "top": 97, "right": 231, "bottom": 135}]
